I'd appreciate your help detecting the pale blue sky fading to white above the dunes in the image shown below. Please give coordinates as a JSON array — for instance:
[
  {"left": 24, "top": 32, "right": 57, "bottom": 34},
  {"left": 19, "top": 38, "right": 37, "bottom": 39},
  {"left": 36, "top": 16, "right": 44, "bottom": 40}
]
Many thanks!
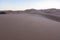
[{"left": 0, "top": 0, "right": 60, "bottom": 10}]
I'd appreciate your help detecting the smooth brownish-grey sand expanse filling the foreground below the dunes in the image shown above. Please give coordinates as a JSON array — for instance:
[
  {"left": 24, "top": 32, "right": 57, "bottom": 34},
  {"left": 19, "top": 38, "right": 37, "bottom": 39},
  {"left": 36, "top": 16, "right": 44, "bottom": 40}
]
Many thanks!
[{"left": 0, "top": 14, "right": 60, "bottom": 40}]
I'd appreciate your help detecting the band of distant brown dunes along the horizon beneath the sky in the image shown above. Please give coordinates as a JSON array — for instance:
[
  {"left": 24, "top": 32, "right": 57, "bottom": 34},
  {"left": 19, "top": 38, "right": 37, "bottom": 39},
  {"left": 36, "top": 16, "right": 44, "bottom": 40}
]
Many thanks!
[{"left": 0, "top": 8, "right": 60, "bottom": 22}]
